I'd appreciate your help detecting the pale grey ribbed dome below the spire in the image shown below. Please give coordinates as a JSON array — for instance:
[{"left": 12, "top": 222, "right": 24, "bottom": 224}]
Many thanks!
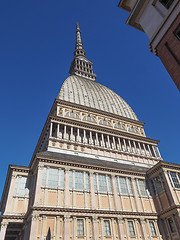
[{"left": 58, "top": 75, "right": 138, "bottom": 120}]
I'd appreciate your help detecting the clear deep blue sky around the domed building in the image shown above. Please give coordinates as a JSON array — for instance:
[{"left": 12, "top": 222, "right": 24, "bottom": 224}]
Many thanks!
[{"left": 0, "top": 0, "right": 180, "bottom": 199}]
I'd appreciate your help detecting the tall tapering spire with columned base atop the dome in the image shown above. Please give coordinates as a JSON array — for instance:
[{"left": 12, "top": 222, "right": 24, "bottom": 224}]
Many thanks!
[{"left": 69, "top": 23, "right": 96, "bottom": 81}]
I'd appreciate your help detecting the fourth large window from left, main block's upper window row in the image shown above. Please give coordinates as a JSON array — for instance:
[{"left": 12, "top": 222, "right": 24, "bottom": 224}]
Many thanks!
[{"left": 116, "top": 177, "right": 133, "bottom": 195}]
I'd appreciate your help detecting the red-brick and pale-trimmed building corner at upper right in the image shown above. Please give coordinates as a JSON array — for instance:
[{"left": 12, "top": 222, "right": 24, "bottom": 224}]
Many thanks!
[{"left": 119, "top": 0, "right": 180, "bottom": 90}]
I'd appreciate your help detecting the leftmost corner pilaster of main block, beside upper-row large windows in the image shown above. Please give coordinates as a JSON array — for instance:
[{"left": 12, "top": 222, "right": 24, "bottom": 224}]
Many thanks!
[{"left": 34, "top": 165, "right": 44, "bottom": 205}]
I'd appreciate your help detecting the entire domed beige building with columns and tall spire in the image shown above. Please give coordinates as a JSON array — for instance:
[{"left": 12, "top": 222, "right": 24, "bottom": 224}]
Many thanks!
[{"left": 0, "top": 24, "right": 180, "bottom": 240}]
